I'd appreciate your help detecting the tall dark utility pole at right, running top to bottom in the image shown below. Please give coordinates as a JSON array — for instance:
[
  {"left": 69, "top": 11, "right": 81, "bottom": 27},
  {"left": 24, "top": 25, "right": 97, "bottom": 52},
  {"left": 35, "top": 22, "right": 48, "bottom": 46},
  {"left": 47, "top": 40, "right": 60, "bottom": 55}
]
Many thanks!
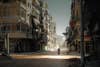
[{"left": 80, "top": 0, "right": 85, "bottom": 67}]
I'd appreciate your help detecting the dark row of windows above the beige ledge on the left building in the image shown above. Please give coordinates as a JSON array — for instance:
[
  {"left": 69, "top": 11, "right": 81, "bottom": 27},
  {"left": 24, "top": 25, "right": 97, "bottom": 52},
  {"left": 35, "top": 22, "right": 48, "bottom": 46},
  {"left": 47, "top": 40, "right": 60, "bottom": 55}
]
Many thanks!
[{"left": 0, "top": 23, "right": 31, "bottom": 33}]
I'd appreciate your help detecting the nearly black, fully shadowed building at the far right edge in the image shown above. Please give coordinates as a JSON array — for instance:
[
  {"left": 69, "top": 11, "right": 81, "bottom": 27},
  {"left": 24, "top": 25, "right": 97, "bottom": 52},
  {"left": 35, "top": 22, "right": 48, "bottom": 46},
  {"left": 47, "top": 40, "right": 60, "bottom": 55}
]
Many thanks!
[{"left": 84, "top": 0, "right": 100, "bottom": 59}]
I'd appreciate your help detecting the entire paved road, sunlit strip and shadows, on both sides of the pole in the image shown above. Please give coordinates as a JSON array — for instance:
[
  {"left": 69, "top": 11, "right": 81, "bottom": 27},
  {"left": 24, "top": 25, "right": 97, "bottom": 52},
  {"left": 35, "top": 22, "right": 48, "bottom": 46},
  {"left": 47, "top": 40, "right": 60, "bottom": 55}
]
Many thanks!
[{"left": 0, "top": 52, "right": 100, "bottom": 67}]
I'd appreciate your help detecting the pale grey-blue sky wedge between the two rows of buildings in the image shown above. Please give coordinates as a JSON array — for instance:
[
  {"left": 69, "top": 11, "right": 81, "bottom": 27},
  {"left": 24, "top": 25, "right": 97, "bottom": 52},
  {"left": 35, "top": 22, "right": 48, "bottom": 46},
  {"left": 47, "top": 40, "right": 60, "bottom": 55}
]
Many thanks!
[{"left": 46, "top": 0, "right": 71, "bottom": 36}]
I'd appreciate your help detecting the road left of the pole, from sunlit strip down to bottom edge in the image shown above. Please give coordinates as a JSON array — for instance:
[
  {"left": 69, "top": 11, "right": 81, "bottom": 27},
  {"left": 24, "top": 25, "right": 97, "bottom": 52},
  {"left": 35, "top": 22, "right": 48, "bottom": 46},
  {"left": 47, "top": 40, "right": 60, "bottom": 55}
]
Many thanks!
[{"left": 0, "top": 55, "right": 80, "bottom": 67}]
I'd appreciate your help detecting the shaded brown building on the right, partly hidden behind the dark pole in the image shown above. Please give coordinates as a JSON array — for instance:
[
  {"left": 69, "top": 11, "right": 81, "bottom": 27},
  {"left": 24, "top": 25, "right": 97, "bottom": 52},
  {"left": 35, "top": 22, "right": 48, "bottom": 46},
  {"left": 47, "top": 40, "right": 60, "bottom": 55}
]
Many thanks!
[{"left": 64, "top": 0, "right": 93, "bottom": 53}]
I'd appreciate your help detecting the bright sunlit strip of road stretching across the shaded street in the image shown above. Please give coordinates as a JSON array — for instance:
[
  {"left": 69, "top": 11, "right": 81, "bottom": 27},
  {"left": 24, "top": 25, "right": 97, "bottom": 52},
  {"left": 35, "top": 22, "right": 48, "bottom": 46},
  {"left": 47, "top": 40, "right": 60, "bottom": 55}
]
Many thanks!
[{"left": 11, "top": 55, "right": 80, "bottom": 59}]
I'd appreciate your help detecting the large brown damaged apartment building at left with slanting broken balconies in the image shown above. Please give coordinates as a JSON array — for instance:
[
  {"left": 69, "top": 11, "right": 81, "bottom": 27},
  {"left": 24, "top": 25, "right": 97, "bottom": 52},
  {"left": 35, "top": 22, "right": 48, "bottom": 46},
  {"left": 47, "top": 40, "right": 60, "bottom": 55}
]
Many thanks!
[{"left": 0, "top": 0, "right": 40, "bottom": 52}]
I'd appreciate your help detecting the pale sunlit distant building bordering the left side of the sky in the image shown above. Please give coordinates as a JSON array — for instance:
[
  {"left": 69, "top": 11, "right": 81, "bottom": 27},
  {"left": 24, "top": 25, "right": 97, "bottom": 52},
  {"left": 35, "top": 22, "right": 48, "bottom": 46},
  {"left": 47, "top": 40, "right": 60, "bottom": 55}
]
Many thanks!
[{"left": 46, "top": 16, "right": 56, "bottom": 51}]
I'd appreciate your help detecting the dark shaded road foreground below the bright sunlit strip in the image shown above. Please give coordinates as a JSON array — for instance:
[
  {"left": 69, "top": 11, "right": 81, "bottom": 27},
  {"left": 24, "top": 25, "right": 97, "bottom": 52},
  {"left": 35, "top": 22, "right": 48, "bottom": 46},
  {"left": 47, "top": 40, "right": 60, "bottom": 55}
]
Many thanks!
[{"left": 0, "top": 57, "right": 79, "bottom": 67}]
